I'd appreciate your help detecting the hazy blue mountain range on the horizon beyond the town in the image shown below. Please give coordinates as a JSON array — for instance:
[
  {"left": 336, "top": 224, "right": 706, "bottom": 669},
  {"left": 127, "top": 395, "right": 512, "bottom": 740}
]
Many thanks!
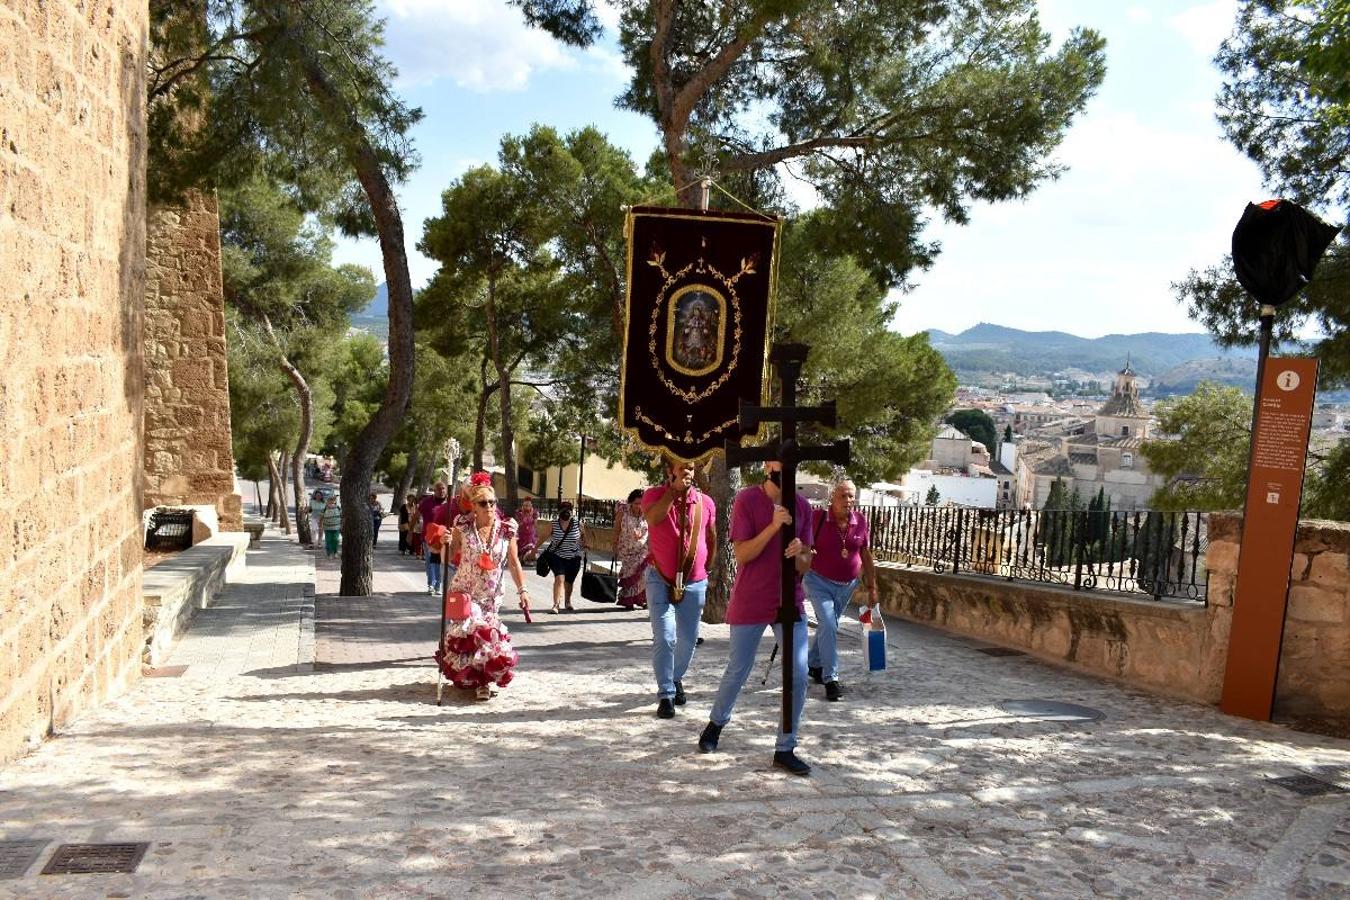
[{"left": 929, "top": 322, "right": 1256, "bottom": 386}]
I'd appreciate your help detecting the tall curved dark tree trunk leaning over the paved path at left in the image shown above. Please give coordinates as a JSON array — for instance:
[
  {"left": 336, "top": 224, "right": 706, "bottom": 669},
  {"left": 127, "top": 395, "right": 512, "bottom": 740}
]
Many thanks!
[{"left": 290, "top": 42, "right": 413, "bottom": 596}]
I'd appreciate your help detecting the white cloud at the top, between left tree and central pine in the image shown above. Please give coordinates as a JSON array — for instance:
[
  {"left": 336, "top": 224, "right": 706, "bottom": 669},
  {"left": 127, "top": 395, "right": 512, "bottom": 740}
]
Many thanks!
[{"left": 379, "top": 0, "right": 576, "bottom": 92}]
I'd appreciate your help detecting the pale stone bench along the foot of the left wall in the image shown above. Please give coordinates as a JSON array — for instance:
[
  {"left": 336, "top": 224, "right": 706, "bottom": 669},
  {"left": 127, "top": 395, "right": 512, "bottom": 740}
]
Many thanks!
[{"left": 142, "top": 532, "right": 250, "bottom": 665}]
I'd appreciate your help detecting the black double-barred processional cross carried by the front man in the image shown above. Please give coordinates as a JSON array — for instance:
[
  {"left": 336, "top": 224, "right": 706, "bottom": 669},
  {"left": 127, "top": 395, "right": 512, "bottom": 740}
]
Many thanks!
[{"left": 726, "top": 344, "right": 849, "bottom": 734}]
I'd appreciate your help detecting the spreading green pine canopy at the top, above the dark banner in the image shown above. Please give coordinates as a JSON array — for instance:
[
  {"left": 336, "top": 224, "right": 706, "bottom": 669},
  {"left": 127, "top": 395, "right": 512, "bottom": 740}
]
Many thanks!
[{"left": 516, "top": 0, "right": 1106, "bottom": 286}]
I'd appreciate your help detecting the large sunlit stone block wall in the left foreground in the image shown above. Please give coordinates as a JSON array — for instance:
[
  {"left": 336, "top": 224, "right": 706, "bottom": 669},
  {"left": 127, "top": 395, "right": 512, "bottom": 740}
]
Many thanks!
[{"left": 0, "top": 0, "right": 147, "bottom": 760}]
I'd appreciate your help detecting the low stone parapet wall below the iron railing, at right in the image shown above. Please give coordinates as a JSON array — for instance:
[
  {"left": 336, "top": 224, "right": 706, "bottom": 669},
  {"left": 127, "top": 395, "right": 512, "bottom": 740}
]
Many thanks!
[{"left": 879, "top": 514, "right": 1350, "bottom": 719}]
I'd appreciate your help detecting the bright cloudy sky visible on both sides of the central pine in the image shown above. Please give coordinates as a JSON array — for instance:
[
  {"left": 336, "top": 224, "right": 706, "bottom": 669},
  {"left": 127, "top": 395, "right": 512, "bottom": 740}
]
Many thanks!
[{"left": 338, "top": 0, "right": 1265, "bottom": 337}]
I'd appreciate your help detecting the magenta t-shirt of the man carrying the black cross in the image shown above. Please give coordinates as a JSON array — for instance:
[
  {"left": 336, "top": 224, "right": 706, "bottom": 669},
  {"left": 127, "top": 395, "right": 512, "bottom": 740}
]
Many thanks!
[{"left": 726, "top": 484, "right": 811, "bottom": 625}]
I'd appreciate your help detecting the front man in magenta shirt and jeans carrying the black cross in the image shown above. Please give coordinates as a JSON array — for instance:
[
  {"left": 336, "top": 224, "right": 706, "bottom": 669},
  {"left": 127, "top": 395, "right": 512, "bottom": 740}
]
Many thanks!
[{"left": 698, "top": 461, "right": 811, "bottom": 775}]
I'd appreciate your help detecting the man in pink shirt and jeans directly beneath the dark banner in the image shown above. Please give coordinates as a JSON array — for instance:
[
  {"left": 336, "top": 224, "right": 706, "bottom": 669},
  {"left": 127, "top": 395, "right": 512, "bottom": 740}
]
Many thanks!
[{"left": 643, "top": 463, "right": 717, "bottom": 719}]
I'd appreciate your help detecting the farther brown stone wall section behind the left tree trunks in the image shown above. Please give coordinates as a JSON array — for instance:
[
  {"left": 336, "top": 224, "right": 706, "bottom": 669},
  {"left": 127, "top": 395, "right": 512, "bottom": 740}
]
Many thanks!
[{"left": 144, "top": 192, "right": 243, "bottom": 532}]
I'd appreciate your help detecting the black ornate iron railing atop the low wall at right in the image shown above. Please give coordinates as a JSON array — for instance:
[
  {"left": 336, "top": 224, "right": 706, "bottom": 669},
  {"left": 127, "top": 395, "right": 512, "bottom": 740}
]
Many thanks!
[{"left": 861, "top": 506, "right": 1208, "bottom": 603}]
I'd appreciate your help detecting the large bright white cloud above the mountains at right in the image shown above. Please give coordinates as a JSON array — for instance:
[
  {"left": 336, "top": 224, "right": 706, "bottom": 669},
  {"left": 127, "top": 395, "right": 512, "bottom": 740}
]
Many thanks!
[{"left": 895, "top": 103, "right": 1261, "bottom": 336}]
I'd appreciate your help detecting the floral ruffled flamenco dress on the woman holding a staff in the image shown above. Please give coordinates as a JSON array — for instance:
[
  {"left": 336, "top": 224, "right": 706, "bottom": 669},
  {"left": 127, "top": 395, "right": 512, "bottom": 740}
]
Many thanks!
[{"left": 436, "top": 518, "right": 520, "bottom": 688}]
